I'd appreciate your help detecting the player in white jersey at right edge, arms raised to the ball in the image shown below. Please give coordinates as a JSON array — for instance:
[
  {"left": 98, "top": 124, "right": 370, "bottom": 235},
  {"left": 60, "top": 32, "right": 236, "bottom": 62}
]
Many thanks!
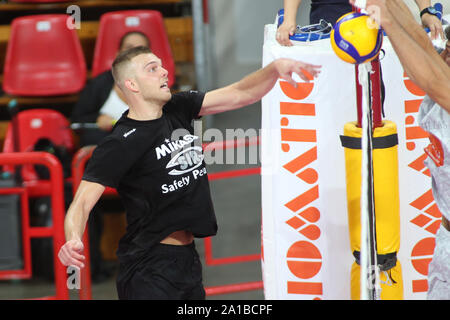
[{"left": 350, "top": 0, "right": 450, "bottom": 300}]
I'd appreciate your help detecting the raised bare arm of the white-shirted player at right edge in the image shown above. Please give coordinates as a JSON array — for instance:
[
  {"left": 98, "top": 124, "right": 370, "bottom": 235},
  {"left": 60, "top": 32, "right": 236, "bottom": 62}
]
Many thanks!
[{"left": 358, "top": 0, "right": 450, "bottom": 112}]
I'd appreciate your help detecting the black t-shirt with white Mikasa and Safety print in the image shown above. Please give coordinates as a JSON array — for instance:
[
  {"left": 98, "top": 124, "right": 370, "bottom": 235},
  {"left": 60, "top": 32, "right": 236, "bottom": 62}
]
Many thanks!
[{"left": 83, "top": 91, "right": 217, "bottom": 262}]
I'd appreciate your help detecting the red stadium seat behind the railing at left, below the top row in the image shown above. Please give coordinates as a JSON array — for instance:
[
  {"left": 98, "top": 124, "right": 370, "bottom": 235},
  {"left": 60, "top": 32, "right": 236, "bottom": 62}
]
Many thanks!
[{"left": 3, "top": 109, "right": 74, "bottom": 181}]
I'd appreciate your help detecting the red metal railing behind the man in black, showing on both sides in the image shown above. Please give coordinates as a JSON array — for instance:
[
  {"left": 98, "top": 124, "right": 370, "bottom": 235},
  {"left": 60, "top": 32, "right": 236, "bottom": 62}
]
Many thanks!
[{"left": 72, "top": 137, "right": 263, "bottom": 299}]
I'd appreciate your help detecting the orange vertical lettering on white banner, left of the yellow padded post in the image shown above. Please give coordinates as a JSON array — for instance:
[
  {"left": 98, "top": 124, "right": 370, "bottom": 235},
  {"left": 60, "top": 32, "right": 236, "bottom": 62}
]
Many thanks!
[{"left": 280, "top": 77, "right": 323, "bottom": 299}]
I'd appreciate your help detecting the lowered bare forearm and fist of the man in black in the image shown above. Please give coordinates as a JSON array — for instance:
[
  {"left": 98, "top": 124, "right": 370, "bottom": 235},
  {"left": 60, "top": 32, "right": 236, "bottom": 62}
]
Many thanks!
[{"left": 58, "top": 180, "right": 105, "bottom": 268}]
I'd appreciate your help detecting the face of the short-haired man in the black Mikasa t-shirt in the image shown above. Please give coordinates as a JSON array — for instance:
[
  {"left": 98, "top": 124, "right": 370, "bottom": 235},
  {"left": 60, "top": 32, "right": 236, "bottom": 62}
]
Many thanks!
[{"left": 132, "top": 53, "right": 172, "bottom": 104}]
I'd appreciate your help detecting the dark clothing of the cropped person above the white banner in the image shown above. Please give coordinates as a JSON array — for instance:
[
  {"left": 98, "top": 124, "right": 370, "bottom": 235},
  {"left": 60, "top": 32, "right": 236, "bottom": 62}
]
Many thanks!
[{"left": 309, "top": 0, "right": 352, "bottom": 25}]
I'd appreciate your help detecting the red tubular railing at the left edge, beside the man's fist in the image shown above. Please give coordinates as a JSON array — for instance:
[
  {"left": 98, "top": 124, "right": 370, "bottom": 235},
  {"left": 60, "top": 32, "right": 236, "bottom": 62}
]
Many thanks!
[{"left": 0, "top": 152, "right": 69, "bottom": 299}]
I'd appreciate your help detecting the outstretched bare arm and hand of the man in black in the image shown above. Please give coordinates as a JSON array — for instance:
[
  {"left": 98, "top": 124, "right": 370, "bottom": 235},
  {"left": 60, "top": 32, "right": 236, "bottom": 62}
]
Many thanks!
[{"left": 199, "top": 59, "right": 320, "bottom": 116}]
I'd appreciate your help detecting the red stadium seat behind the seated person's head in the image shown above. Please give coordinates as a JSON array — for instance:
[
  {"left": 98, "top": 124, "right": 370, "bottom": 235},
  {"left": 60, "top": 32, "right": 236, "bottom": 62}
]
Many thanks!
[{"left": 92, "top": 10, "right": 175, "bottom": 87}]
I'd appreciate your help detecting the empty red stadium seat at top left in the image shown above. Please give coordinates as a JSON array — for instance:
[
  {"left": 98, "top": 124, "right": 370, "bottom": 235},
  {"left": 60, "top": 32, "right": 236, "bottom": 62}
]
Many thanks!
[{"left": 3, "top": 14, "right": 86, "bottom": 96}]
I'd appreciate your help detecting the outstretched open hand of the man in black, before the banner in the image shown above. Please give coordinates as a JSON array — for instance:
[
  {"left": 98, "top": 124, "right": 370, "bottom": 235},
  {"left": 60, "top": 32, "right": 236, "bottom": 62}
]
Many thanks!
[{"left": 276, "top": 59, "right": 322, "bottom": 87}]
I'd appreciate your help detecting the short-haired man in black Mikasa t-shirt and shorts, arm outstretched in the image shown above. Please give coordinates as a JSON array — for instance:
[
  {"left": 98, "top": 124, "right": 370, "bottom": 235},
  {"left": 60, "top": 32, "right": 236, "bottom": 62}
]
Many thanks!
[{"left": 59, "top": 47, "right": 320, "bottom": 299}]
